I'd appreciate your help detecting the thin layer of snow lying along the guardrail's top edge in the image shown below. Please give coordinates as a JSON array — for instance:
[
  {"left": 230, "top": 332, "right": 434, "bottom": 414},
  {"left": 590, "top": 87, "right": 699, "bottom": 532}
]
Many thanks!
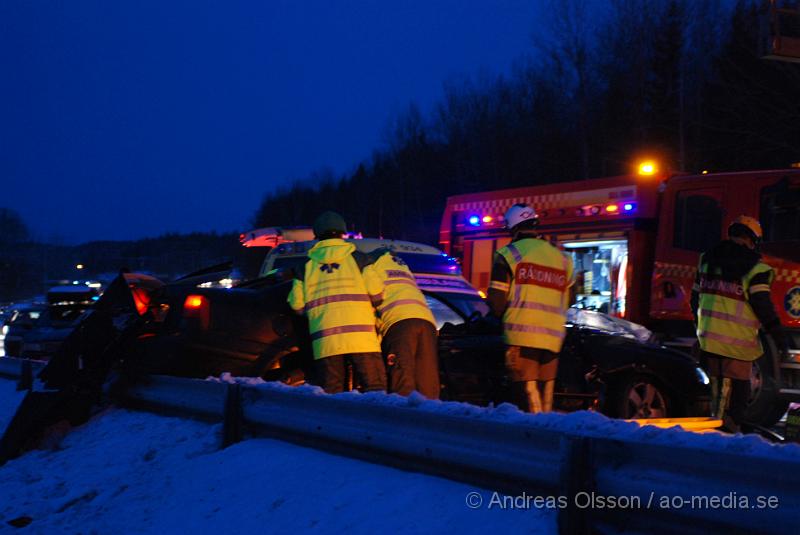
[{"left": 208, "top": 374, "right": 800, "bottom": 461}]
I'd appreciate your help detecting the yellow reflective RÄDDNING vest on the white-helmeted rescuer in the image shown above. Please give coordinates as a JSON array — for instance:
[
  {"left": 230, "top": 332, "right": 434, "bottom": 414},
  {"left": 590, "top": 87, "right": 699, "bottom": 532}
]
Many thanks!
[{"left": 497, "top": 238, "right": 573, "bottom": 353}]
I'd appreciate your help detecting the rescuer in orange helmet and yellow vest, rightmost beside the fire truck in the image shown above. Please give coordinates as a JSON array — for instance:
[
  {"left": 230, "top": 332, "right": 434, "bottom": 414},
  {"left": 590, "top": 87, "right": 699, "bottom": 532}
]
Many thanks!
[{"left": 692, "top": 216, "right": 787, "bottom": 432}]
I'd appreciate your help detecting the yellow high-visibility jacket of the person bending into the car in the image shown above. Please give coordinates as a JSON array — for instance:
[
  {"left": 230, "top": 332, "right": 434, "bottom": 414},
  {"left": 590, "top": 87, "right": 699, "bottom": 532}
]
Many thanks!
[{"left": 364, "top": 252, "right": 436, "bottom": 336}]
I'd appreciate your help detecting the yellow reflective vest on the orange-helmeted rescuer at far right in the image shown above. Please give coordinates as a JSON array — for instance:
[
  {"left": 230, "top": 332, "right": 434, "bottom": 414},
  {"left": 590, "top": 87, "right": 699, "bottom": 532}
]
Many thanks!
[{"left": 697, "top": 257, "right": 772, "bottom": 361}]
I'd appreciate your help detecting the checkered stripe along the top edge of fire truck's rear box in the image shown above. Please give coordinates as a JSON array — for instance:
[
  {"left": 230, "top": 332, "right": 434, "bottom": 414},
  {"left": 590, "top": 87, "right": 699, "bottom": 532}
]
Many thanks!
[{"left": 453, "top": 186, "right": 636, "bottom": 213}]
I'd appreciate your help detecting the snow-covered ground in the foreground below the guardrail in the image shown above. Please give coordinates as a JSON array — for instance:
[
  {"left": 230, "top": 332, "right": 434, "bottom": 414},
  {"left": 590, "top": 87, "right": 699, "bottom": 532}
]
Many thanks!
[{"left": 0, "top": 388, "right": 556, "bottom": 534}]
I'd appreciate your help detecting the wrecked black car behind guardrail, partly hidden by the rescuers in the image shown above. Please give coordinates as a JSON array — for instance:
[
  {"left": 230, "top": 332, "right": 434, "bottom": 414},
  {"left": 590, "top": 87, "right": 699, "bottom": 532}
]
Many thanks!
[{"left": 134, "top": 273, "right": 710, "bottom": 418}]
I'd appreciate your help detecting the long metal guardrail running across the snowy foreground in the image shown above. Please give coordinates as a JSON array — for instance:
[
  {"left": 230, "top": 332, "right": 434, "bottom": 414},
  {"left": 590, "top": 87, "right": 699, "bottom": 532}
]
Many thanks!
[{"left": 0, "top": 359, "right": 800, "bottom": 534}]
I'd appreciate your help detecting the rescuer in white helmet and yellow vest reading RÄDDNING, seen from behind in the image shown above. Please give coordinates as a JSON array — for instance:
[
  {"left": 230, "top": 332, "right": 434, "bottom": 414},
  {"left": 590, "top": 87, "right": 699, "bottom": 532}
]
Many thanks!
[{"left": 488, "top": 204, "right": 573, "bottom": 412}]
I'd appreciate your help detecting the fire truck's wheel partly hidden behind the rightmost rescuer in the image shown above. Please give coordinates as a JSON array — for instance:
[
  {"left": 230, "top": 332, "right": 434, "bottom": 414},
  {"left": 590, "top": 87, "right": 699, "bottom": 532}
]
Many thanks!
[{"left": 744, "top": 337, "right": 789, "bottom": 427}]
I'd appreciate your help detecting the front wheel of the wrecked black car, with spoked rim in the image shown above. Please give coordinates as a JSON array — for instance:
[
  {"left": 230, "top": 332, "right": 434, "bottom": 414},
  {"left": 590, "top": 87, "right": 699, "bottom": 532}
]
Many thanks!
[{"left": 606, "top": 374, "right": 675, "bottom": 420}]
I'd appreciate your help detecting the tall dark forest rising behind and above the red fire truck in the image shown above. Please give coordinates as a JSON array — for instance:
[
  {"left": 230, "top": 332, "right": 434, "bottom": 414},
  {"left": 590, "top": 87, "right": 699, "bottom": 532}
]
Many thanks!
[{"left": 253, "top": 0, "right": 800, "bottom": 243}]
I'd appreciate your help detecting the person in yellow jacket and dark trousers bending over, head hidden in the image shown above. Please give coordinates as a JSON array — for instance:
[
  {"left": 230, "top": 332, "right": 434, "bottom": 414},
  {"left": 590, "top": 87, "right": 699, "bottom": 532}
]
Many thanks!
[{"left": 365, "top": 249, "right": 440, "bottom": 399}]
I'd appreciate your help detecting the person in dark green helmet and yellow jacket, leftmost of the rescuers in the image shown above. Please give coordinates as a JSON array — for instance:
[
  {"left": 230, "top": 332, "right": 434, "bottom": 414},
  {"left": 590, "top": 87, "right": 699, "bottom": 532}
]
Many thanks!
[{"left": 287, "top": 212, "right": 386, "bottom": 393}]
